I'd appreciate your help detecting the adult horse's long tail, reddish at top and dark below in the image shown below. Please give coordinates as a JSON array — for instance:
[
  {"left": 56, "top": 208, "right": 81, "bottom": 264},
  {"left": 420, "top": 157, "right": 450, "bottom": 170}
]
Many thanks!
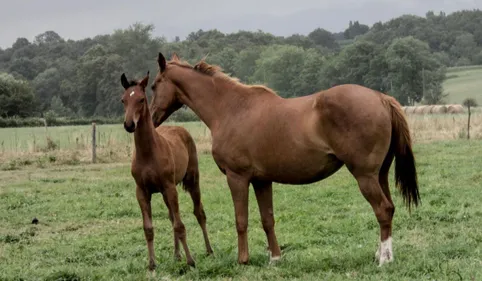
[{"left": 383, "top": 95, "right": 421, "bottom": 210}]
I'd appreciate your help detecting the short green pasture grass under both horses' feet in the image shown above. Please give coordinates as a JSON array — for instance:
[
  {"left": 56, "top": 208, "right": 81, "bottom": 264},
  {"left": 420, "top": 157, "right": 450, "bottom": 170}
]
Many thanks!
[{"left": 0, "top": 139, "right": 482, "bottom": 280}]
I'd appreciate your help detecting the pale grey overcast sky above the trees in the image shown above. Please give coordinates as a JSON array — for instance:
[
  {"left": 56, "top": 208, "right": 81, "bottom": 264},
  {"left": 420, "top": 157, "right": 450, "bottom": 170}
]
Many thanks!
[{"left": 0, "top": 0, "right": 482, "bottom": 48}]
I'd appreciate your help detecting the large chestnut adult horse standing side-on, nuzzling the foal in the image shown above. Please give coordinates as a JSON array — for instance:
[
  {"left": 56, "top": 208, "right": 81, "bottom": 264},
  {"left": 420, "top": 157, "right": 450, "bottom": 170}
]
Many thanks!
[{"left": 151, "top": 53, "right": 420, "bottom": 265}]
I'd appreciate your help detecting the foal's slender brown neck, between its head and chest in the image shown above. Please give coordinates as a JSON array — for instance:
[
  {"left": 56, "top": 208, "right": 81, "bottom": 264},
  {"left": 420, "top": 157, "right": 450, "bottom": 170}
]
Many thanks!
[{"left": 134, "top": 109, "right": 156, "bottom": 158}]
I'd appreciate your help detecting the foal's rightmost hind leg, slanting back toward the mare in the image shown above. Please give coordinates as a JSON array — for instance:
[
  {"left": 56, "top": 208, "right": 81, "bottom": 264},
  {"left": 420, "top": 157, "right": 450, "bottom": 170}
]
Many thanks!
[{"left": 183, "top": 169, "right": 213, "bottom": 255}]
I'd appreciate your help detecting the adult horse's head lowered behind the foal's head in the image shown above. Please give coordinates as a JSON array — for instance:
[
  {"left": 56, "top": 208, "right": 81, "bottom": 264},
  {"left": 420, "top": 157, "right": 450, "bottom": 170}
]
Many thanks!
[{"left": 150, "top": 53, "right": 183, "bottom": 127}]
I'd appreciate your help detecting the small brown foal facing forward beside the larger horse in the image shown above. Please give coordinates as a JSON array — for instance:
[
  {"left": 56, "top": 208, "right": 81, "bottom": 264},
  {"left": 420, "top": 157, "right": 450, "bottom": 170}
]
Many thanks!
[{"left": 121, "top": 72, "right": 213, "bottom": 270}]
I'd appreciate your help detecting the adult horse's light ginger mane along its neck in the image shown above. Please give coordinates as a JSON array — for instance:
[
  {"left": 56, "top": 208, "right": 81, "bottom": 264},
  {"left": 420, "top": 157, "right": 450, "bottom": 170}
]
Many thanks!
[{"left": 168, "top": 59, "right": 276, "bottom": 95}]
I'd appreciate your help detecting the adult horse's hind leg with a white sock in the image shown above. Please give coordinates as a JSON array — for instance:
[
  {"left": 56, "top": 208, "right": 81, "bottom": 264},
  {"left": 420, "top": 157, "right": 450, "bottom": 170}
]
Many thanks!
[{"left": 355, "top": 172, "right": 395, "bottom": 266}]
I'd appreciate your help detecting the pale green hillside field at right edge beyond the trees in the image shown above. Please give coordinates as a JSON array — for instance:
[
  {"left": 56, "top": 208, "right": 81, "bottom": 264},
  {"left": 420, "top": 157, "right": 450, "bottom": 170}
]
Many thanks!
[{"left": 443, "top": 65, "right": 482, "bottom": 105}]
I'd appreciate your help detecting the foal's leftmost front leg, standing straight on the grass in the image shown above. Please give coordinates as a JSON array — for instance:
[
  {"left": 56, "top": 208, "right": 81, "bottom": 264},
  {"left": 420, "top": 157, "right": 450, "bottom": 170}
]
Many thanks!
[{"left": 136, "top": 186, "right": 156, "bottom": 270}]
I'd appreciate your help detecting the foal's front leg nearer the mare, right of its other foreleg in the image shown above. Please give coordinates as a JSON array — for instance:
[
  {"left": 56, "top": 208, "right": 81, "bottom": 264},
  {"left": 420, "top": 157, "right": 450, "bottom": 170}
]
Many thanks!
[{"left": 164, "top": 184, "right": 195, "bottom": 266}]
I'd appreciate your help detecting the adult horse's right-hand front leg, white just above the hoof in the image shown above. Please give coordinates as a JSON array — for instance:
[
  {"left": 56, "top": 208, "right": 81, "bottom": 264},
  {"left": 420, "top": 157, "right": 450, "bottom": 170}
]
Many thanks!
[{"left": 253, "top": 181, "right": 281, "bottom": 262}]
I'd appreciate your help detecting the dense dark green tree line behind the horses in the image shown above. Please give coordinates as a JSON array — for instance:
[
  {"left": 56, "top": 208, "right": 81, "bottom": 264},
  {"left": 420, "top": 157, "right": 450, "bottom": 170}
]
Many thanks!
[{"left": 0, "top": 10, "right": 482, "bottom": 118}]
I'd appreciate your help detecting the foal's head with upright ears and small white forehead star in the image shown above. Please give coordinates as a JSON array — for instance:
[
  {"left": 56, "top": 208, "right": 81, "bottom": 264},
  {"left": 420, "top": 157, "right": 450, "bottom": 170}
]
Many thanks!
[{"left": 121, "top": 71, "right": 150, "bottom": 133}]
